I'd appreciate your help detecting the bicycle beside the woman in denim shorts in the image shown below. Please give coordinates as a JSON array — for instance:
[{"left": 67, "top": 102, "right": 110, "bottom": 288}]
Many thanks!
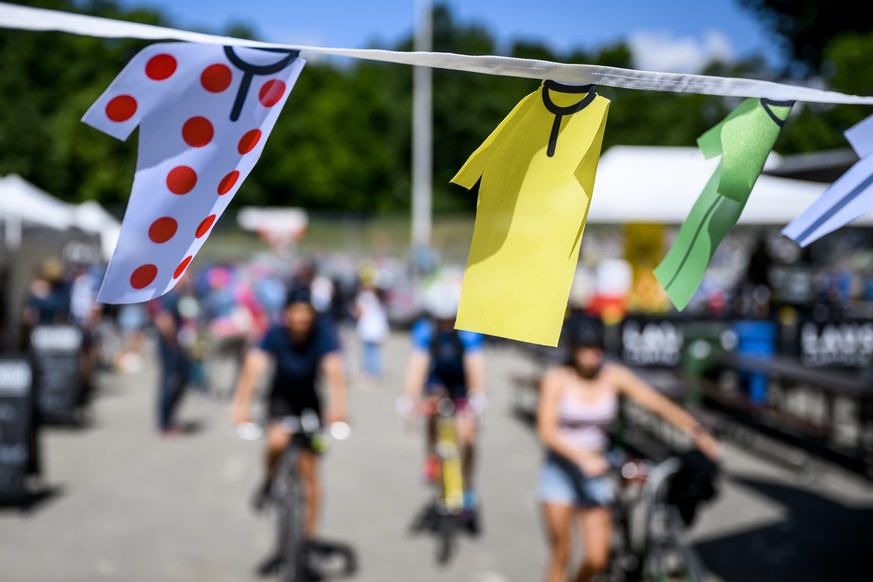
[{"left": 607, "top": 457, "right": 705, "bottom": 582}]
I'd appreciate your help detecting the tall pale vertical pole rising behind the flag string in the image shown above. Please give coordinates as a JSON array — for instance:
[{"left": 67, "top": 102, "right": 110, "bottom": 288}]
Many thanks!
[{"left": 412, "top": 0, "right": 433, "bottom": 262}]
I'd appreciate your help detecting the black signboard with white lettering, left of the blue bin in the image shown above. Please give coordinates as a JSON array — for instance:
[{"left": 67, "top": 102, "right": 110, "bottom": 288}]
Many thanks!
[{"left": 620, "top": 318, "right": 684, "bottom": 367}]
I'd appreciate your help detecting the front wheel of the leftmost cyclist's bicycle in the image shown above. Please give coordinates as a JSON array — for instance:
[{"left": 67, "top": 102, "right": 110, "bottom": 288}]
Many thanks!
[{"left": 273, "top": 446, "right": 306, "bottom": 582}]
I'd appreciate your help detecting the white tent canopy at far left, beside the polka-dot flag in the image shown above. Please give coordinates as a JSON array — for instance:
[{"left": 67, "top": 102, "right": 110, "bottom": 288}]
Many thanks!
[{"left": 0, "top": 174, "right": 121, "bottom": 259}]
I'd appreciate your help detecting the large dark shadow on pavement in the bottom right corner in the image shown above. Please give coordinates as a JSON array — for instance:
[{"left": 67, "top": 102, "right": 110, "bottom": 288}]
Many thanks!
[{"left": 696, "top": 477, "right": 873, "bottom": 582}]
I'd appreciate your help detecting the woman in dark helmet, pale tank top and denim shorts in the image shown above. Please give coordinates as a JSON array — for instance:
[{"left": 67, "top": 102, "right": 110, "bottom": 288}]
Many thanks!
[{"left": 537, "top": 316, "right": 720, "bottom": 582}]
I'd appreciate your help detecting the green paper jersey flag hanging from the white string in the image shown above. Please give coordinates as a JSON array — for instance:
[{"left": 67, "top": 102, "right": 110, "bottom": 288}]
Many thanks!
[{"left": 655, "top": 99, "right": 793, "bottom": 310}]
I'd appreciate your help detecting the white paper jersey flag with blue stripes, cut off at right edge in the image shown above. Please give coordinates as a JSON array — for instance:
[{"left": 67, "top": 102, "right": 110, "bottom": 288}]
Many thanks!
[{"left": 782, "top": 116, "right": 873, "bottom": 247}]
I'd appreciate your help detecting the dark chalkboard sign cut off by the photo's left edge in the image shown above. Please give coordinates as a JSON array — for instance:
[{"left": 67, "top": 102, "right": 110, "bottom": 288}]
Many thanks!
[{"left": 0, "top": 357, "right": 33, "bottom": 496}]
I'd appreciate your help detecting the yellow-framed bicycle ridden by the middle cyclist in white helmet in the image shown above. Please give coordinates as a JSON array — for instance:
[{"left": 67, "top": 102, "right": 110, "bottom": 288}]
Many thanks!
[{"left": 410, "top": 396, "right": 484, "bottom": 565}]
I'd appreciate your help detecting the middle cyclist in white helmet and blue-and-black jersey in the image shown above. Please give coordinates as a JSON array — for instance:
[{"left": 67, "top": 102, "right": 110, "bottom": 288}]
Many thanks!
[{"left": 400, "top": 279, "right": 485, "bottom": 533}]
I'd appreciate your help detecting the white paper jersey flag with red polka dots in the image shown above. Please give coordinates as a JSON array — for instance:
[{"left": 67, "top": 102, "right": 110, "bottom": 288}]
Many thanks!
[{"left": 82, "top": 43, "right": 305, "bottom": 303}]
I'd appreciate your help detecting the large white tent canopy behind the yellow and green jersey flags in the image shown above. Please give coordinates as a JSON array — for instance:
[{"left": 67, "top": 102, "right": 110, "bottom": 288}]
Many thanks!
[{"left": 588, "top": 146, "right": 873, "bottom": 226}]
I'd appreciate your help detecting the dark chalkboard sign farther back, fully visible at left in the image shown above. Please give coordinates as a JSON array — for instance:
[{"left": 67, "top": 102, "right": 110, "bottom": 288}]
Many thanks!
[{"left": 30, "top": 325, "right": 82, "bottom": 422}]
